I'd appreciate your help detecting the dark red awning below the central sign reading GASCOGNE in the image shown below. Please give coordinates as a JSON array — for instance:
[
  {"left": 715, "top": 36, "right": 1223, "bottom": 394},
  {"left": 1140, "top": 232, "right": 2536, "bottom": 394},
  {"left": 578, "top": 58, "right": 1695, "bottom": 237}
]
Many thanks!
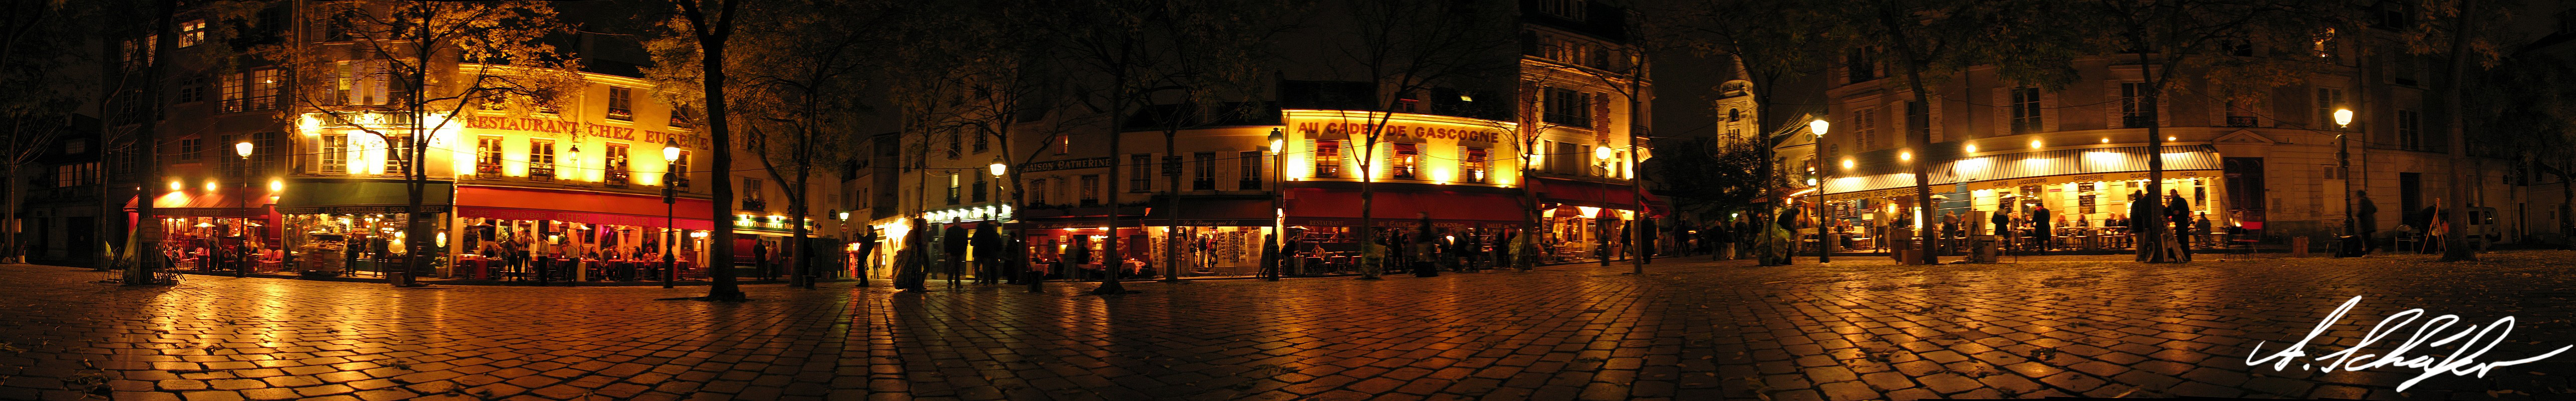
[{"left": 1288, "top": 187, "right": 1527, "bottom": 226}]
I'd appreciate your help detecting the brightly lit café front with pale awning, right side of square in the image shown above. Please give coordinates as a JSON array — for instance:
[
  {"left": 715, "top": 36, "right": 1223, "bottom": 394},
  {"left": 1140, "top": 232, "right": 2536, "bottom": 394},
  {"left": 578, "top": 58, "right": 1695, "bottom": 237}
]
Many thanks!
[{"left": 1806, "top": 146, "right": 2236, "bottom": 249}]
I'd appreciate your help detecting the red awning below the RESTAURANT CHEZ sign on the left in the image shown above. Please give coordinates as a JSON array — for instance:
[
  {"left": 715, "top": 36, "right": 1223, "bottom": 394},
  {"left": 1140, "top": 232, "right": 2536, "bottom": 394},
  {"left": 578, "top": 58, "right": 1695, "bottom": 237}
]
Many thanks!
[{"left": 456, "top": 185, "right": 716, "bottom": 229}]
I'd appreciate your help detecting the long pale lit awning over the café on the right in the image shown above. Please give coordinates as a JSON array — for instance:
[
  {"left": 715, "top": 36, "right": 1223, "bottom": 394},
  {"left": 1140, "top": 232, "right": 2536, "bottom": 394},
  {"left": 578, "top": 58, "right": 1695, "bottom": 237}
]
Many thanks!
[{"left": 1824, "top": 144, "right": 2220, "bottom": 200}]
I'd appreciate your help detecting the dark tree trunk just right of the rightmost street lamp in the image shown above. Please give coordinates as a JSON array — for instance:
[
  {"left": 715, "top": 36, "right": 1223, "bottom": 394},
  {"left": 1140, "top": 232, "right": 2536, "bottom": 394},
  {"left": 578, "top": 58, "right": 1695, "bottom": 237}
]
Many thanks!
[{"left": 2434, "top": 0, "right": 2478, "bottom": 262}]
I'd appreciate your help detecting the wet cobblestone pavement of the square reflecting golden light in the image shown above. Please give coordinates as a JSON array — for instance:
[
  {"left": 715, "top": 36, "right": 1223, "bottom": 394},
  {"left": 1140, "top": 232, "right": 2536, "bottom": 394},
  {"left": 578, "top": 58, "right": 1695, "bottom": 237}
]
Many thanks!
[{"left": 0, "top": 252, "right": 2576, "bottom": 401}]
